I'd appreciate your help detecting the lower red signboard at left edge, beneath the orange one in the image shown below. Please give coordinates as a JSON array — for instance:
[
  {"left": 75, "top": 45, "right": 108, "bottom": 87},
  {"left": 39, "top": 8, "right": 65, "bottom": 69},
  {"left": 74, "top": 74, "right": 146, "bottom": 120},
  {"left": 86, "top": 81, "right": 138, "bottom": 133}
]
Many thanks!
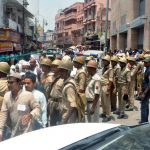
[{"left": 0, "top": 42, "right": 13, "bottom": 53}]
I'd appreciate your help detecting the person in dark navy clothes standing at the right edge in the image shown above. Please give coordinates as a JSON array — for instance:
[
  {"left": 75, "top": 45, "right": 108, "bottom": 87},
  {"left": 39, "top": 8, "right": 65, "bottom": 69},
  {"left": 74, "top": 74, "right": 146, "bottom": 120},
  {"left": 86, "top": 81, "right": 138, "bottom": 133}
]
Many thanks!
[{"left": 140, "top": 57, "right": 150, "bottom": 123}]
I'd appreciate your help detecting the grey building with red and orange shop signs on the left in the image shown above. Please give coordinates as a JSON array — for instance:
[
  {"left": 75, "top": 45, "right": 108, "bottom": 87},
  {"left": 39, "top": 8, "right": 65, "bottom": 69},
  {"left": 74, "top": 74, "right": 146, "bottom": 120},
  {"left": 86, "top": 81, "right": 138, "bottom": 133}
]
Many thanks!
[{"left": 0, "top": 0, "right": 34, "bottom": 53}]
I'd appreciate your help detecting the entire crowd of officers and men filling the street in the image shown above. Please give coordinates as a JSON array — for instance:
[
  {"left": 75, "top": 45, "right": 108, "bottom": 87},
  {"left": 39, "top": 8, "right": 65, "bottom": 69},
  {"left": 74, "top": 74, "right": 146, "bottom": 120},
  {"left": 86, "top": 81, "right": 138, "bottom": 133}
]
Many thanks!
[{"left": 0, "top": 48, "right": 150, "bottom": 141}]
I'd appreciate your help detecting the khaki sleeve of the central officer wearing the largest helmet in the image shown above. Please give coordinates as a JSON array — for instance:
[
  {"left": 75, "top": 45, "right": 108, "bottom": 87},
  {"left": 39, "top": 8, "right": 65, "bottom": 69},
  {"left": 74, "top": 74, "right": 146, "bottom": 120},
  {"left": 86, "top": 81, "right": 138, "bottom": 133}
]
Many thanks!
[{"left": 66, "top": 86, "right": 77, "bottom": 107}]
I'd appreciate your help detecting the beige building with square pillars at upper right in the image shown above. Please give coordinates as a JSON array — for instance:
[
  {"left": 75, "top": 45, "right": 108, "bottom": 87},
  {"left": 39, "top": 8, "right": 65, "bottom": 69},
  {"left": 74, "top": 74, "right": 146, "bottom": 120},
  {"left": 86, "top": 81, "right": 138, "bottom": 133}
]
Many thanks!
[{"left": 110, "top": 0, "right": 150, "bottom": 50}]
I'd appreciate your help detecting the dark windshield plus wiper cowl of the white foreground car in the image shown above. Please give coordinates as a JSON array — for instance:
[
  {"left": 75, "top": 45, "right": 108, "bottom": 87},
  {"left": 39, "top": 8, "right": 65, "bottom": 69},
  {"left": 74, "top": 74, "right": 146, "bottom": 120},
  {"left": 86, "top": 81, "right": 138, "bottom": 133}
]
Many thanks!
[{"left": 62, "top": 124, "right": 150, "bottom": 150}]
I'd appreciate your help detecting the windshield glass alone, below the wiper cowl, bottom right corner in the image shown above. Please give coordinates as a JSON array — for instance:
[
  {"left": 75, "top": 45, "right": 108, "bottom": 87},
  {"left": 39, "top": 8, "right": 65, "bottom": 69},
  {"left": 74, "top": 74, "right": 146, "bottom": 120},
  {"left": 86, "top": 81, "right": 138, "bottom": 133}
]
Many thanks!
[{"left": 101, "top": 124, "right": 150, "bottom": 150}]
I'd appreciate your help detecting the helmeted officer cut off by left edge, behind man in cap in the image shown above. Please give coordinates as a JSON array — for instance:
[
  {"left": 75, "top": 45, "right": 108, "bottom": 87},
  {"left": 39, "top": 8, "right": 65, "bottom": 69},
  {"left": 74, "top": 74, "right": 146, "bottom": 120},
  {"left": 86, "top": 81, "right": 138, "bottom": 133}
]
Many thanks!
[{"left": 0, "top": 62, "right": 10, "bottom": 110}]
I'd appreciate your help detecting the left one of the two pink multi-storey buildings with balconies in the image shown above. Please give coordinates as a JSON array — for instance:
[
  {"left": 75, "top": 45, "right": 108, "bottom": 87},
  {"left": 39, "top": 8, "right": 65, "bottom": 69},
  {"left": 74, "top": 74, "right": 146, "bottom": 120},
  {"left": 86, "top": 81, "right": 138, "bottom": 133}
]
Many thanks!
[{"left": 55, "top": 2, "right": 84, "bottom": 48}]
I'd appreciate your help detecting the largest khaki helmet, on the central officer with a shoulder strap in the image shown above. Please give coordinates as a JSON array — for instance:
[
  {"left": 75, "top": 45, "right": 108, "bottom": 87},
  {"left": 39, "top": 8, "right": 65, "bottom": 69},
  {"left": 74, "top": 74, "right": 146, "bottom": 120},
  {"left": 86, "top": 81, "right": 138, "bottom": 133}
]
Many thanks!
[{"left": 58, "top": 60, "right": 73, "bottom": 71}]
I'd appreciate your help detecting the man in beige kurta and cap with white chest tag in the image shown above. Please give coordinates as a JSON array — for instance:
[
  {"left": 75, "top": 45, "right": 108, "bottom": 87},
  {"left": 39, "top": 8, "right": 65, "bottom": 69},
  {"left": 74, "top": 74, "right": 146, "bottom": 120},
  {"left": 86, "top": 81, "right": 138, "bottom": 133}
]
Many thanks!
[{"left": 0, "top": 73, "right": 40, "bottom": 140}]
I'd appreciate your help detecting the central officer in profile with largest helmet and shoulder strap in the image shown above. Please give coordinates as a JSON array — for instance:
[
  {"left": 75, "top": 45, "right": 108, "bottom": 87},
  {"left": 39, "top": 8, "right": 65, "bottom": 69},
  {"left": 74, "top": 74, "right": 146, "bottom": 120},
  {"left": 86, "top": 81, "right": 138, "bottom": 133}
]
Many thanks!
[{"left": 59, "top": 61, "right": 79, "bottom": 124}]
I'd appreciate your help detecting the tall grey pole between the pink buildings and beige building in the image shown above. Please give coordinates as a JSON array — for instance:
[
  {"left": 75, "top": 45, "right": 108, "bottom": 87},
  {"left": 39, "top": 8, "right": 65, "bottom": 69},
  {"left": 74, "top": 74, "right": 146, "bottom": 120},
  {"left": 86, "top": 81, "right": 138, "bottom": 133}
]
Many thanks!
[{"left": 105, "top": 0, "right": 109, "bottom": 52}]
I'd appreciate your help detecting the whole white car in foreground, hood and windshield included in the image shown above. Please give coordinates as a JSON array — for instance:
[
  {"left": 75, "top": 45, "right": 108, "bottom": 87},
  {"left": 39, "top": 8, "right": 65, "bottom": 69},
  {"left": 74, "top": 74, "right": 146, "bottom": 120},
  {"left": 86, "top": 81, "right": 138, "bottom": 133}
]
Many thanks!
[{"left": 0, "top": 123, "right": 150, "bottom": 150}]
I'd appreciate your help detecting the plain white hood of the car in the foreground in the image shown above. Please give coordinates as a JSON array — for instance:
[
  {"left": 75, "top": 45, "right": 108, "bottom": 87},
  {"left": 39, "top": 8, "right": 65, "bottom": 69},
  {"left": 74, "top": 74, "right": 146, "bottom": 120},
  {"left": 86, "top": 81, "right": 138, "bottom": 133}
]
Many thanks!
[{"left": 0, "top": 123, "right": 119, "bottom": 150}]
